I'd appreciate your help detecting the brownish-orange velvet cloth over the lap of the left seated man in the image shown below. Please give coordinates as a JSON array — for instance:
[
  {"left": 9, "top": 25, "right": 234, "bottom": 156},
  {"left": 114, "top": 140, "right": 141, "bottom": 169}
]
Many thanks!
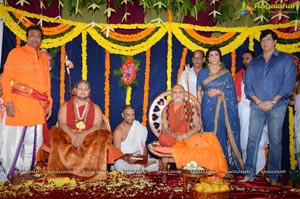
[{"left": 48, "top": 127, "right": 123, "bottom": 181}]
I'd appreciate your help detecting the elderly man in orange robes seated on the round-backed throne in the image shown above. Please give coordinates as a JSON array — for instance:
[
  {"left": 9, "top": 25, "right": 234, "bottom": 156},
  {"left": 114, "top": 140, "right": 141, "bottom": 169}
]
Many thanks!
[{"left": 158, "top": 85, "right": 228, "bottom": 176}]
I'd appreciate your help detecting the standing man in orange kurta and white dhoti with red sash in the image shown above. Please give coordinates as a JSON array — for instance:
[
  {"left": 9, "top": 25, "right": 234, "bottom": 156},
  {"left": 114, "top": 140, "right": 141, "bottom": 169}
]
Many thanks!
[{"left": 1, "top": 26, "right": 52, "bottom": 184}]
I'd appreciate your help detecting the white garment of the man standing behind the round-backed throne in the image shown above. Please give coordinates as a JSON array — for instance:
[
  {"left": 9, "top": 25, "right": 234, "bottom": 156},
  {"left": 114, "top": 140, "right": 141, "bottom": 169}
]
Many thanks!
[{"left": 178, "top": 67, "right": 197, "bottom": 97}]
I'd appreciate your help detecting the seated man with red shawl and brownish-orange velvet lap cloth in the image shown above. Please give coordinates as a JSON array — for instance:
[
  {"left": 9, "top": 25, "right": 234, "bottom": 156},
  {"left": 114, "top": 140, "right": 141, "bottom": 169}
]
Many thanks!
[{"left": 48, "top": 80, "right": 123, "bottom": 181}]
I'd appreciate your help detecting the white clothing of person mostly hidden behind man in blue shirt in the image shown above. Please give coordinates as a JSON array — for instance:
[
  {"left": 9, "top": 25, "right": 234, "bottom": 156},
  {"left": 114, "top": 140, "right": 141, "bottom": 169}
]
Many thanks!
[{"left": 238, "top": 82, "right": 268, "bottom": 174}]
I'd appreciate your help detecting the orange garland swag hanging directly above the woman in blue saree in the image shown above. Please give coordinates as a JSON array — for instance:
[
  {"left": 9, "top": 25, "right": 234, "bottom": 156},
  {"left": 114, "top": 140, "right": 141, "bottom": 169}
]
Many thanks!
[{"left": 184, "top": 29, "right": 236, "bottom": 45}]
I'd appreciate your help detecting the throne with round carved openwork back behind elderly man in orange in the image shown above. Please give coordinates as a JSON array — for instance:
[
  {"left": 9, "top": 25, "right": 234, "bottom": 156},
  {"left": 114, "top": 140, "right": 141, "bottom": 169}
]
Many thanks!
[{"left": 148, "top": 90, "right": 200, "bottom": 183}]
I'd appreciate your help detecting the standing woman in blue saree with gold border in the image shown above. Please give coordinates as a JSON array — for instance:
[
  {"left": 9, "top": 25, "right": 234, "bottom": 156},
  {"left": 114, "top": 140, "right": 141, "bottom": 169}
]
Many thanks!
[{"left": 197, "top": 46, "right": 244, "bottom": 170}]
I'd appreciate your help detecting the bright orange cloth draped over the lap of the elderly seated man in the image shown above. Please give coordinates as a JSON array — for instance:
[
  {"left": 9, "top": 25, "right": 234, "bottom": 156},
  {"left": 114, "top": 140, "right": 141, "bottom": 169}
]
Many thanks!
[{"left": 172, "top": 133, "right": 228, "bottom": 177}]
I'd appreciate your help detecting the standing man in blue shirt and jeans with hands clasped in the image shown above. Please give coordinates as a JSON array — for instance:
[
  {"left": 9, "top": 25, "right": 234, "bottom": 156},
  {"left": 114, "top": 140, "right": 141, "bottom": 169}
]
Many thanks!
[{"left": 241, "top": 30, "right": 296, "bottom": 186}]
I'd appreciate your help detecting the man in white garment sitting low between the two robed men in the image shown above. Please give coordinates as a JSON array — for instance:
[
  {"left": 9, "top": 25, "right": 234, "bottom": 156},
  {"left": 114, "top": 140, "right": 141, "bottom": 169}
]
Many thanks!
[{"left": 114, "top": 105, "right": 158, "bottom": 173}]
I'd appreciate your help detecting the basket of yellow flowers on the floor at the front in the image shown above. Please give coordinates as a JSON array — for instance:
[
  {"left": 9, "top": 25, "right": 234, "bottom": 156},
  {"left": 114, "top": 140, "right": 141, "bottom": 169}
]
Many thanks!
[{"left": 192, "top": 175, "right": 230, "bottom": 199}]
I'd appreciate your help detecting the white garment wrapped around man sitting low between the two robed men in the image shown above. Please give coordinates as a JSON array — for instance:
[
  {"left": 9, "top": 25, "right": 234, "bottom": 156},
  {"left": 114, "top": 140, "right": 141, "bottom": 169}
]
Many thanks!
[{"left": 114, "top": 120, "right": 158, "bottom": 173}]
